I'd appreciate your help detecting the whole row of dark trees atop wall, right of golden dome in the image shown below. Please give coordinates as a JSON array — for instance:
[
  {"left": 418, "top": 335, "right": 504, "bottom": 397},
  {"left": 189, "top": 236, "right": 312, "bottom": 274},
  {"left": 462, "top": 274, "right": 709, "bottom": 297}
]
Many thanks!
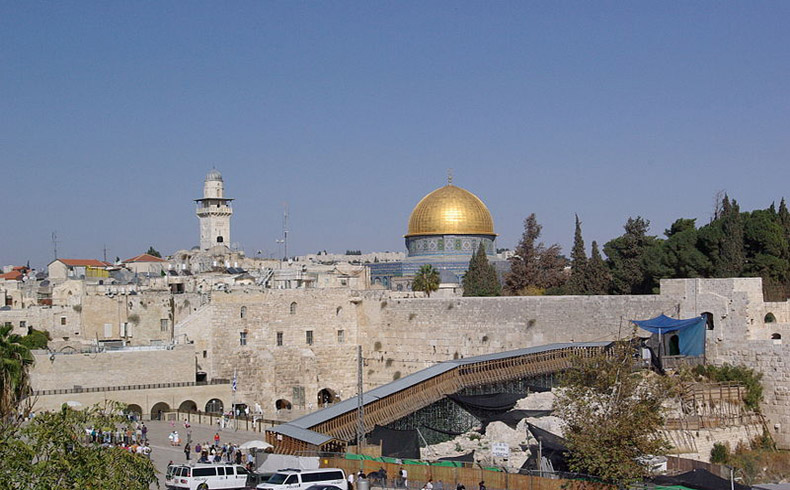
[{"left": 448, "top": 194, "right": 790, "bottom": 301}]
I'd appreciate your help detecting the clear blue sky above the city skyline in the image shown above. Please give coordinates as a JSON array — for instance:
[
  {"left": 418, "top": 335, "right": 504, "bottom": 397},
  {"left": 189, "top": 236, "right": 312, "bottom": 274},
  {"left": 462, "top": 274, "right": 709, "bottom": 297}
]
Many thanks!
[{"left": 0, "top": 0, "right": 790, "bottom": 266}]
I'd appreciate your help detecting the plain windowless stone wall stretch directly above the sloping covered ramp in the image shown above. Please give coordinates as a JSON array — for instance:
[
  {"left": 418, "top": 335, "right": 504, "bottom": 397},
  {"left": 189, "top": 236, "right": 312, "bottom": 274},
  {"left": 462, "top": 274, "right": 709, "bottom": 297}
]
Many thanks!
[{"left": 358, "top": 294, "right": 678, "bottom": 386}]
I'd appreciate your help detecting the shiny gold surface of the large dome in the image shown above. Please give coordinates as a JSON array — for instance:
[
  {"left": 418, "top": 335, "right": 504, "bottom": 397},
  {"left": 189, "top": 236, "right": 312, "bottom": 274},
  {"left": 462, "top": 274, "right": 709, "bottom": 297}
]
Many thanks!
[{"left": 406, "top": 184, "right": 495, "bottom": 237}]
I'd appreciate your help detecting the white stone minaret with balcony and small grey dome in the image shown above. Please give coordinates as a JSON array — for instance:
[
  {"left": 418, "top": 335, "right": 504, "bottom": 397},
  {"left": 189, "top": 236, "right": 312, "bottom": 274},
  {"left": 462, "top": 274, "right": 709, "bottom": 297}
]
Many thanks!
[{"left": 195, "top": 169, "right": 233, "bottom": 250}]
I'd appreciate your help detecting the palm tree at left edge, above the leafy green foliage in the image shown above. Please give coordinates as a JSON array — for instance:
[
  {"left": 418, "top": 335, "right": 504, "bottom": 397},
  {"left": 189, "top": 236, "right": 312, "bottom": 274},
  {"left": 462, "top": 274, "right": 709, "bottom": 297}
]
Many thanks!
[{"left": 0, "top": 325, "right": 33, "bottom": 417}]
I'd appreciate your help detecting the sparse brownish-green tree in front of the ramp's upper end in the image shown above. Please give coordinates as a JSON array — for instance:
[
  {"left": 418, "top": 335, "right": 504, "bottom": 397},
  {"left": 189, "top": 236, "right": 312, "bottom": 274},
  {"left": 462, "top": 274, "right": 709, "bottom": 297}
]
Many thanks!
[{"left": 554, "top": 342, "right": 671, "bottom": 485}]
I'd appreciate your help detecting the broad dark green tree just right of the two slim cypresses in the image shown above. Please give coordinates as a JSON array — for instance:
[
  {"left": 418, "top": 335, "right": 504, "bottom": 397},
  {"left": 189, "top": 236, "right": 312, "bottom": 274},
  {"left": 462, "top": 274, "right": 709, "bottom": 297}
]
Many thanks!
[{"left": 603, "top": 216, "right": 660, "bottom": 294}]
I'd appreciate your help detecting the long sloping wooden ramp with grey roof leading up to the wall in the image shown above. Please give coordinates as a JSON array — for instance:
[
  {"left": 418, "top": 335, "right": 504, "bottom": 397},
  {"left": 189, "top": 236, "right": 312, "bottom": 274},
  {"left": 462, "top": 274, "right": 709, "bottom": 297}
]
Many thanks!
[{"left": 266, "top": 342, "right": 612, "bottom": 454}]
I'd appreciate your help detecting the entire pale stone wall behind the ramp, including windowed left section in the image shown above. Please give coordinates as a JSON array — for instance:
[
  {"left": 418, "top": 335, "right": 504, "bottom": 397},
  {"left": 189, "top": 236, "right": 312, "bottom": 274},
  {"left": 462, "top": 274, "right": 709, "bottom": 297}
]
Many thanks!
[{"left": 169, "top": 278, "right": 790, "bottom": 447}]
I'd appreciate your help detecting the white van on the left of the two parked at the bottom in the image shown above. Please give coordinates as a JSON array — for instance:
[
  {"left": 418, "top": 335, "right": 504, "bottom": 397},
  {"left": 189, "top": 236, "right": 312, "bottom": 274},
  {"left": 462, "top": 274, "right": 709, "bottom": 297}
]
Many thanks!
[{"left": 165, "top": 464, "right": 248, "bottom": 490}]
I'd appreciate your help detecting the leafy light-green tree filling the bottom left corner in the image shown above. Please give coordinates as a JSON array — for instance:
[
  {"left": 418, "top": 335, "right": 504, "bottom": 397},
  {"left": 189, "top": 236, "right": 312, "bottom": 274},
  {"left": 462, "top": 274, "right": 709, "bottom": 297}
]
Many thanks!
[{"left": 0, "top": 404, "right": 156, "bottom": 490}]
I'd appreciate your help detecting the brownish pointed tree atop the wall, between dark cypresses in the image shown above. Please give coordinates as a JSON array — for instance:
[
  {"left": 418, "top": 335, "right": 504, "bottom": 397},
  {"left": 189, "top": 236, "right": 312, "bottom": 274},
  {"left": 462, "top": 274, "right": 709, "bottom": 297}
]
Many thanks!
[{"left": 504, "top": 213, "right": 568, "bottom": 295}]
